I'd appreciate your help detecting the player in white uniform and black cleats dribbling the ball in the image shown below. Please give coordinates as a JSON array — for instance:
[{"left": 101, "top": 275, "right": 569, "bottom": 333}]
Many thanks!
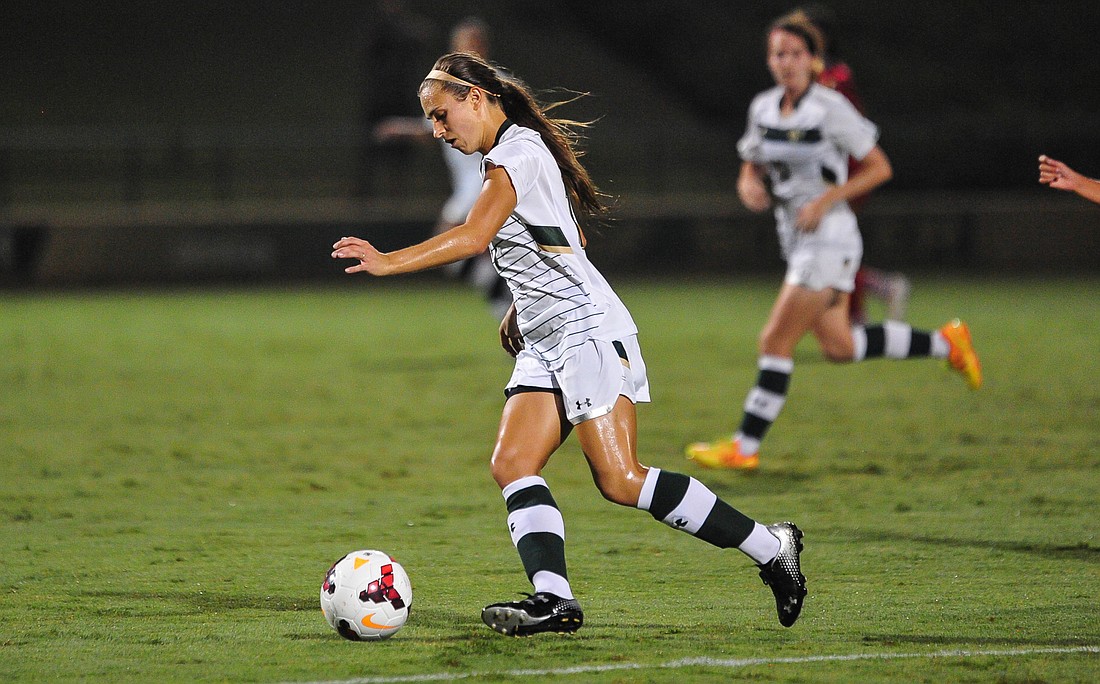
[{"left": 332, "top": 53, "right": 806, "bottom": 636}]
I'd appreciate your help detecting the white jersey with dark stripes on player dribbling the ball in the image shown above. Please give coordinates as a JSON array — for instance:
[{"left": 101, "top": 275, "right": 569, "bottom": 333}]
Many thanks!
[{"left": 483, "top": 121, "right": 638, "bottom": 371}]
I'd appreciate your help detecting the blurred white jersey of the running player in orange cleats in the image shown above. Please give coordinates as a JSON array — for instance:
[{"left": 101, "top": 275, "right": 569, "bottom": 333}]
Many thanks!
[{"left": 737, "top": 84, "right": 879, "bottom": 254}]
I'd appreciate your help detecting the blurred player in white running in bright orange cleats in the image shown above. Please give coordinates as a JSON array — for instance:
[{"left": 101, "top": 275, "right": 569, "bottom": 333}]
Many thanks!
[{"left": 688, "top": 15, "right": 981, "bottom": 468}]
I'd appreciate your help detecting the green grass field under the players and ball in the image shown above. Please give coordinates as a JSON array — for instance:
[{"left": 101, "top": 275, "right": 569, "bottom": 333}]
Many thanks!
[{"left": 0, "top": 277, "right": 1100, "bottom": 682}]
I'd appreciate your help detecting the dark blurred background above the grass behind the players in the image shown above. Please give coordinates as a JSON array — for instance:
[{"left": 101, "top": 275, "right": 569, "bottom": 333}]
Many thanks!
[{"left": 0, "top": 0, "right": 1100, "bottom": 279}]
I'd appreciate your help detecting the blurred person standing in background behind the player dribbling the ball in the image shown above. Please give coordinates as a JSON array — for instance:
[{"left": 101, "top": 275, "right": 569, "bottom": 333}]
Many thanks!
[{"left": 375, "top": 16, "right": 512, "bottom": 320}]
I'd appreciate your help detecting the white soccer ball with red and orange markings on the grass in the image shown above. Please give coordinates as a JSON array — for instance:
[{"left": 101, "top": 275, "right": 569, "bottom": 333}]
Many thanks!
[{"left": 321, "top": 550, "right": 413, "bottom": 641}]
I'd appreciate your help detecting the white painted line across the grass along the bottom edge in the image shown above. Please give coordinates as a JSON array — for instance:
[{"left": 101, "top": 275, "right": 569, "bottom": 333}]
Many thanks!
[{"left": 288, "top": 646, "right": 1100, "bottom": 684}]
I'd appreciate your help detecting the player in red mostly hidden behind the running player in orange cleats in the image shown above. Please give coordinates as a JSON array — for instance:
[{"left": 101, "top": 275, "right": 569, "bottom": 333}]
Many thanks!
[{"left": 792, "top": 3, "right": 910, "bottom": 323}]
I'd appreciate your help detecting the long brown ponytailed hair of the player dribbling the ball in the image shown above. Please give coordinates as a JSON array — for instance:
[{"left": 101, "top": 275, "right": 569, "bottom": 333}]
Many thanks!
[{"left": 420, "top": 53, "right": 609, "bottom": 218}]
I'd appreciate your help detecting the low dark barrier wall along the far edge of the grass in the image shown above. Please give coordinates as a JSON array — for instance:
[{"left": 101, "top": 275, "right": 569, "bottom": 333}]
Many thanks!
[{"left": 0, "top": 191, "right": 1100, "bottom": 286}]
